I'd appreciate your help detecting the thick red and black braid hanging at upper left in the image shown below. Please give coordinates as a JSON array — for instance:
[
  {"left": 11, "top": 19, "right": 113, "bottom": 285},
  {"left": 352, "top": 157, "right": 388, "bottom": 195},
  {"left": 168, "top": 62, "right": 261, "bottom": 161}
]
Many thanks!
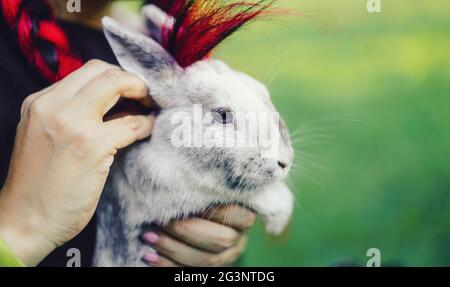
[{"left": 0, "top": 0, "right": 82, "bottom": 82}]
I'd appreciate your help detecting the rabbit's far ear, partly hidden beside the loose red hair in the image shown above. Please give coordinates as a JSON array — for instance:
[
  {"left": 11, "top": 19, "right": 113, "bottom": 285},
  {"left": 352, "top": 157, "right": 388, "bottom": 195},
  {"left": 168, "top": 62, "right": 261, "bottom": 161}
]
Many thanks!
[{"left": 141, "top": 4, "right": 175, "bottom": 43}]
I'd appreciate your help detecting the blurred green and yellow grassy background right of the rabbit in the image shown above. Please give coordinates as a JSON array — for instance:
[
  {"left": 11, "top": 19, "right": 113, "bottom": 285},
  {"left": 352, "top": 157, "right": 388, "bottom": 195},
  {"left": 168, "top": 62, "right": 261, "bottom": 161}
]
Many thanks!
[{"left": 128, "top": 0, "right": 450, "bottom": 266}]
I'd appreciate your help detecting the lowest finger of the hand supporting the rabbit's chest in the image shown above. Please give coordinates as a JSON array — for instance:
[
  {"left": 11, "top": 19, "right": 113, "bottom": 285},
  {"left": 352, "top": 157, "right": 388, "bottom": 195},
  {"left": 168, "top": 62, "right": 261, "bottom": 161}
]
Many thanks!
[{"left": 144, "top": 233, "right": 246, "bottom": 266}]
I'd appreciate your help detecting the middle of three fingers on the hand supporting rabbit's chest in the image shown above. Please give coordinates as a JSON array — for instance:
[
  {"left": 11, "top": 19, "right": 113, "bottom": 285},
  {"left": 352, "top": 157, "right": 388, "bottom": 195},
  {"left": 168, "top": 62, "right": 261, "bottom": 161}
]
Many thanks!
[{"left": 163, "top": 218, "right": 240, "bottom": 252}]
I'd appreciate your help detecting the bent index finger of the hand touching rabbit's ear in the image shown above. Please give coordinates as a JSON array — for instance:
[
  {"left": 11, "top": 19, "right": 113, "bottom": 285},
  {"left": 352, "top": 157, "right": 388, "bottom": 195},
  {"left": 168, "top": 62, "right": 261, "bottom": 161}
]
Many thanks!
[{"left": 77, "top": 69, "right": 148, "bottom": 118}]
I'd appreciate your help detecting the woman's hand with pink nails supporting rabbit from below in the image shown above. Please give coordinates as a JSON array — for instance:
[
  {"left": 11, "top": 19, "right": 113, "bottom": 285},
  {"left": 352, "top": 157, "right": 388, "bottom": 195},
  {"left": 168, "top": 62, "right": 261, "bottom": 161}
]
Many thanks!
[{"left": 142, "top": 205, "right": 255, "bottom": 267}]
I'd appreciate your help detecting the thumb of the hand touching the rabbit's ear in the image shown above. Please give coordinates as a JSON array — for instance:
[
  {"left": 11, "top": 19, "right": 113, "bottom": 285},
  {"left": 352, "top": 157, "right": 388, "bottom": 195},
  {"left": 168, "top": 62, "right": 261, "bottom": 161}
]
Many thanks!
[{"left": 99, "top": 116, "right": 155, "bottom": 149}]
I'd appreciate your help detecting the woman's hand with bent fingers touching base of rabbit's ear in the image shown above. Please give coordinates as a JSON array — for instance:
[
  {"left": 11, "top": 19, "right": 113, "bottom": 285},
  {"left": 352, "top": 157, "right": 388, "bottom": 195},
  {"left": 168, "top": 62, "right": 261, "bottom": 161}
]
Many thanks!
[{"left": 0, "top": 61, "right": 153, "bottom": 265}]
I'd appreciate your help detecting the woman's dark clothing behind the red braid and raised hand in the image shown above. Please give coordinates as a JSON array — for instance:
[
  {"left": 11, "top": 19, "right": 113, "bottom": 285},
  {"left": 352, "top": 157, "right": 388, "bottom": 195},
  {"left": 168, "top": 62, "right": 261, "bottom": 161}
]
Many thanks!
[{"left": 0, "top": 19, "right": 117, "bottom": 266}]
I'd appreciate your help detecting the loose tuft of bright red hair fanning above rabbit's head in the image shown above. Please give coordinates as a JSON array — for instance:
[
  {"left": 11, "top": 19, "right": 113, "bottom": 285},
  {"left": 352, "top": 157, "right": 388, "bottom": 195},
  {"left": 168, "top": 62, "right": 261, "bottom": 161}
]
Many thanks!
[{"left": 150, "top": 0, "right": 273, "bottom": 67}]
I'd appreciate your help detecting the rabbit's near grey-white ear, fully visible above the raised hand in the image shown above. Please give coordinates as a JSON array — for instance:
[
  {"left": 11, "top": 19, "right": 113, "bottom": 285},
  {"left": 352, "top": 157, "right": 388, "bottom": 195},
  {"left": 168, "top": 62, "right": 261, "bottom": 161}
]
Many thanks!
[{"left": 102, "top": 17, "right": 181, "bottom": 107}]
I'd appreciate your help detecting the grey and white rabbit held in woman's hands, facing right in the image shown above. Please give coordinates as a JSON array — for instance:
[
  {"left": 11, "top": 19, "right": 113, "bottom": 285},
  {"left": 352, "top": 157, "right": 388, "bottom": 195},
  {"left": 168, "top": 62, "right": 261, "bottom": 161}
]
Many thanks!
[{"left": 93, "top": 7, "right": 294, "bottom": 266}]
